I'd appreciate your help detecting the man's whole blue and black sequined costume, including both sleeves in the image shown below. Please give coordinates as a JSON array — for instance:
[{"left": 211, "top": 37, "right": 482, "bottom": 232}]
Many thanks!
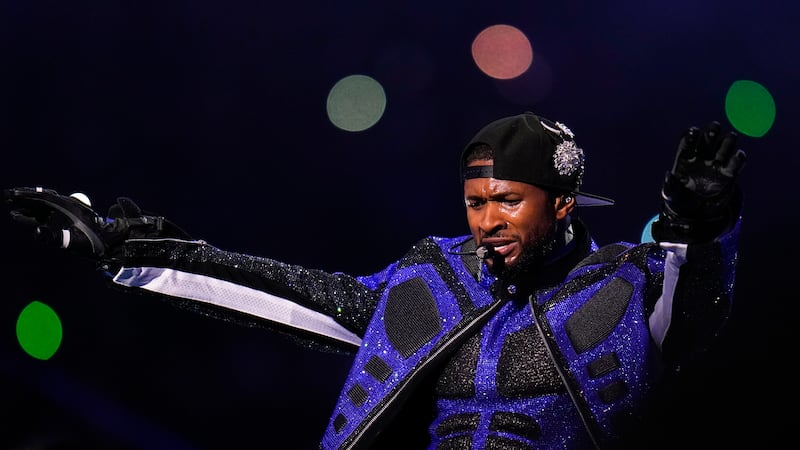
[{"left": 113, "top": 215, "right": 738, "bottom": 449}]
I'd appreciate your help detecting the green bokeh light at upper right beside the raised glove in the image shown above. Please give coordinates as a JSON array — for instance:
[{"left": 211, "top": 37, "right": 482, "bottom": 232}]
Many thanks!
[{"left": 725, "top": 80, "right": 775, "bottom": 137}]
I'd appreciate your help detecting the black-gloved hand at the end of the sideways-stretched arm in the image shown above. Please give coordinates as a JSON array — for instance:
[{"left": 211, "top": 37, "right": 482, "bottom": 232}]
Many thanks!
[{"left": 3, "top": 187, "right": 191, "bottom": 270}]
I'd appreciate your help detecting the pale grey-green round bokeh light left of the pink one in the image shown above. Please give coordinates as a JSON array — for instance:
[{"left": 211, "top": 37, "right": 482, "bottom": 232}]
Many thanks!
[{"left": 327, "top": 75, "right": 386, "bottom": 131}]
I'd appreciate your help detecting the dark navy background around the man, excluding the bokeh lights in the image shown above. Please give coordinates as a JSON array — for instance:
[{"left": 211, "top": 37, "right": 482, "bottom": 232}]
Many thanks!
[{"left": 0, "top": 0, "right": 800, "bottom": 450}]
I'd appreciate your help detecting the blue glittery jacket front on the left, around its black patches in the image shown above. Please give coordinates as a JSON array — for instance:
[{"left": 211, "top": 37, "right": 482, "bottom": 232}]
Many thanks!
[{"left": 322, "top": 237, "right": 500, "bottom": 448}]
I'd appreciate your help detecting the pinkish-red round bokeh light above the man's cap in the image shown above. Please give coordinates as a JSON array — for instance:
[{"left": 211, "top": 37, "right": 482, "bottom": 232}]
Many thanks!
[{"left": 472, "top": 25, "right": 533, "bottom": 80}]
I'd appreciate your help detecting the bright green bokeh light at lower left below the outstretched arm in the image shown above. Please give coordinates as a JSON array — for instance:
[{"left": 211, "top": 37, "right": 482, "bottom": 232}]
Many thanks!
[{"left": 17, "top": 301, "right": 62, "bottom": 360}]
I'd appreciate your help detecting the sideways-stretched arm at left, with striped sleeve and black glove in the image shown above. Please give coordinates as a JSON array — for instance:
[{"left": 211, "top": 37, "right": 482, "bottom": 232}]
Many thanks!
[{"left": 4, "top": 188, "right": 379, "bottom": 351}]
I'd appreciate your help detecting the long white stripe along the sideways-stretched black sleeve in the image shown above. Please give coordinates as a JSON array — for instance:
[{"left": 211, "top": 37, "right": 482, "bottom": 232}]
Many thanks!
[{"left": 113, "top": 267, "right": 361, "bottom": 347}]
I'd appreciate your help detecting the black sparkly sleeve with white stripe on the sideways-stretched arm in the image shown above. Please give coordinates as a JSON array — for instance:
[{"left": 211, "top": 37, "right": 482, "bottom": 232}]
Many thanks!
[{"left": 112, "top": 239, "right": 385, "bottom": 351}]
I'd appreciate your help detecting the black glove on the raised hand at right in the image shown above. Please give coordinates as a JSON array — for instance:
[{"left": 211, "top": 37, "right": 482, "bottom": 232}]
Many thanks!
[{"left": 651, "top": 122, "right": 746, "bottom": 243}]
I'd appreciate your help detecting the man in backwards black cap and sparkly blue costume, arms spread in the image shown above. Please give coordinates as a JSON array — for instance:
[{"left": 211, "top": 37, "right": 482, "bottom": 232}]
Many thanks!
[{"left": 6, "top": 113, "right": 745, "bottom": 449}]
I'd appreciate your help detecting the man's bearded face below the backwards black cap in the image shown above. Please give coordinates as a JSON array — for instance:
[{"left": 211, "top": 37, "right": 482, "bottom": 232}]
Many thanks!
[{"left": 464, "top": 161, "right": 566, "bottom": 276}]
